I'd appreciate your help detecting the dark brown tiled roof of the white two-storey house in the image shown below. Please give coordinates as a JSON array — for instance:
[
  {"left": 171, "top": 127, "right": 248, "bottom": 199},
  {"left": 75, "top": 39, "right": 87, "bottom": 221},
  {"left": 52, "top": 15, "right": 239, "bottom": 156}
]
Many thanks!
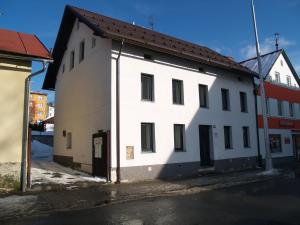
[{"left": 43, "top": 6, "right": 254, "bottom": 89}]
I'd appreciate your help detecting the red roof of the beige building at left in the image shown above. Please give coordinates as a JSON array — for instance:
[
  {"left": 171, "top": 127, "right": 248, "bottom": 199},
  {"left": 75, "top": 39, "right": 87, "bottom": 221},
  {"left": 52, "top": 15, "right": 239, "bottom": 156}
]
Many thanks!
[{"left": 0, "top": 29, "right": 51, "bottom": 59}]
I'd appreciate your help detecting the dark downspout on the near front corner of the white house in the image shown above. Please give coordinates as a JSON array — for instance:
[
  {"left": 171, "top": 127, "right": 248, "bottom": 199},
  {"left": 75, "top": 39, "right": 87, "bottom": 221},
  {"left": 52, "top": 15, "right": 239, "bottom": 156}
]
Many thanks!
[{"left": 116, "top": 39, "right": 124, "bottom": 183}]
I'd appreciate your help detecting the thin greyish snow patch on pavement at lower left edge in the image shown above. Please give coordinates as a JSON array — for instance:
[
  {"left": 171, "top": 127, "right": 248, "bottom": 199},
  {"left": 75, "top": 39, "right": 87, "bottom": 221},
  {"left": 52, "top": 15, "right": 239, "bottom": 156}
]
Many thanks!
[{"left": 0, "top": 195, "right": 38, "bottom": 218}]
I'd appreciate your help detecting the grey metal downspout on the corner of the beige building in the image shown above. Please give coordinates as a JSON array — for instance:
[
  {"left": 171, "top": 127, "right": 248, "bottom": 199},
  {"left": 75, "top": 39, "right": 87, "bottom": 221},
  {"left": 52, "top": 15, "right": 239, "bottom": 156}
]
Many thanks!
[{"left": 21, "top": 60, "right": 50, "bottom": 192}]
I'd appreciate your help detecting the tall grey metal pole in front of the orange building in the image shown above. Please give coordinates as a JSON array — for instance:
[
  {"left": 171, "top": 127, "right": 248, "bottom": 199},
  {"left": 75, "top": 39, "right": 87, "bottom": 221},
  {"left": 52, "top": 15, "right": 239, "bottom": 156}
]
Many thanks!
[{"left": 252, "top": 0, "right": 273, "bottom": 171}]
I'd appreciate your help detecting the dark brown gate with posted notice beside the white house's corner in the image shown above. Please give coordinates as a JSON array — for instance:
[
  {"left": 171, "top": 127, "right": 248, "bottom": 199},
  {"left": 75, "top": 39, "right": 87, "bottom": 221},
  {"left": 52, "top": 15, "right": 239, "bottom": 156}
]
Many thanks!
[{"left": 93, "top": 131, "right": 108, "bottom": 177}]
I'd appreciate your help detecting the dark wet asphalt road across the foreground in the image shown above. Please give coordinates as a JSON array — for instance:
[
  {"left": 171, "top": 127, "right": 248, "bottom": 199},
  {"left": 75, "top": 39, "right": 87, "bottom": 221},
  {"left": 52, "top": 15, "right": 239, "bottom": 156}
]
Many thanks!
[{"left": 1, "top": 178, "right": 300, "bottom": 225}]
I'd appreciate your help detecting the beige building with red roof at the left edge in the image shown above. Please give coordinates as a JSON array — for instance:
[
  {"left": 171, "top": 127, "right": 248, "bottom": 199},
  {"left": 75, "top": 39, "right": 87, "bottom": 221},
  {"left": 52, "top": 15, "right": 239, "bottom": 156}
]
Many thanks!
[{"left": 0, "top": 29, "right": 50, "bottom": 186}]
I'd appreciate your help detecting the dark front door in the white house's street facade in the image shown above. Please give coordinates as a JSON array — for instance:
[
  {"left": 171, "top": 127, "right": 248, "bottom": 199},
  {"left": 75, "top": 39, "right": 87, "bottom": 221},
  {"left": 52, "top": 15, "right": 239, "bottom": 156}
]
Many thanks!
[{"left": 199, "top": 125, "right": 212, "bottom": 166}]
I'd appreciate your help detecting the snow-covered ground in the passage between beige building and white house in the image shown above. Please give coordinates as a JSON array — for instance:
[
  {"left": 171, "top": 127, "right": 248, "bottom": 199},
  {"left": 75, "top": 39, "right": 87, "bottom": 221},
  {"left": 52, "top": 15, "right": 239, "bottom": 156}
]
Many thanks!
[{"left": 31, "top": 140, "right": 106, "bottom": 185}]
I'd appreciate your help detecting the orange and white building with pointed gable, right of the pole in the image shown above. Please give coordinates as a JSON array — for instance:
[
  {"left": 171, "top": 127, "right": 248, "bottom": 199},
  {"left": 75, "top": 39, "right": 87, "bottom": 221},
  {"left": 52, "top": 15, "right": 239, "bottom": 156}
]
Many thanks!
[{"left": 241, "top": 50, "right": 300, "bottom": 163}]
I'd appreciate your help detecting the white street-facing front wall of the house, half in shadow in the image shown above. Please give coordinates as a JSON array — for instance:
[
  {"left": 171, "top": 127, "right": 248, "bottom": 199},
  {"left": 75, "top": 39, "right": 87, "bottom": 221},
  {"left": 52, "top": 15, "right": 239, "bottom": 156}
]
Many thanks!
[{"left": 112, "top": 47, "right": 257, "bottom": 167}]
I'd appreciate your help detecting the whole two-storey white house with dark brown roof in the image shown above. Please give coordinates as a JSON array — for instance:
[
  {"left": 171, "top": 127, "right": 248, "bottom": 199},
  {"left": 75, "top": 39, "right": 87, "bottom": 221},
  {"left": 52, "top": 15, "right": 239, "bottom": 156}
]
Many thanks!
[{"left": 43, "top": 6, "right": 258, "bottom": 180}]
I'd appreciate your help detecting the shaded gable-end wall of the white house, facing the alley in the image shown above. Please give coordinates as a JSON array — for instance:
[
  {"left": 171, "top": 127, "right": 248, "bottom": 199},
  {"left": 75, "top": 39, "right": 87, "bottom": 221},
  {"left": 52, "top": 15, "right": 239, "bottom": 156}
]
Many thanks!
[{"left": 54, "top": 23, "right": 111, "bottom": 172}]
